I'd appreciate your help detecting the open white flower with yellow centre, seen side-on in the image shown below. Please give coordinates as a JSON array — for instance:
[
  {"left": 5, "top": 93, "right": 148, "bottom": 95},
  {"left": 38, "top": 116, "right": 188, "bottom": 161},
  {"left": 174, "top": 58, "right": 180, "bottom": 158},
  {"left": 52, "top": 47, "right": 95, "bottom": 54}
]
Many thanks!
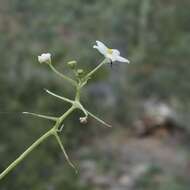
[{"left": 93, "top": 41, "right": 129, "bottom": 63}]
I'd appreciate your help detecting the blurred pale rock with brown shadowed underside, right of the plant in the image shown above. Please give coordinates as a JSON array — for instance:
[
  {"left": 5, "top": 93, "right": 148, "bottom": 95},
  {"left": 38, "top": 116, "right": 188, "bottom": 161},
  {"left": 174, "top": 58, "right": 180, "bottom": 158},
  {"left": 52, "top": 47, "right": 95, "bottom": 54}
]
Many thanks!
[{"left": 133, "top": 99, "right": 178, "bottom": 136}]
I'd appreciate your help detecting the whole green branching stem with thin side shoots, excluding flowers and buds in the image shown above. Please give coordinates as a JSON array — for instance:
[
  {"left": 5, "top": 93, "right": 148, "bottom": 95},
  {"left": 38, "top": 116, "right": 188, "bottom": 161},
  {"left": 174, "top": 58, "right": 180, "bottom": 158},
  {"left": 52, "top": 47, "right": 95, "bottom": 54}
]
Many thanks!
[{"left": 0, "top": 59, "right": 110, "bottom": 180}]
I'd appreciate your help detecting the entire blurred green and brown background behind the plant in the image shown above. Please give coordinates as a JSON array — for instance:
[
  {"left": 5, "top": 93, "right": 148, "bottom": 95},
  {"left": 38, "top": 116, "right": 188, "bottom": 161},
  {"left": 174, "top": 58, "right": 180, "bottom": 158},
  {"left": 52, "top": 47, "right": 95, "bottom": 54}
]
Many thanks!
[{"left": 0, "top": 0, "right": 190, "bottom": 190}]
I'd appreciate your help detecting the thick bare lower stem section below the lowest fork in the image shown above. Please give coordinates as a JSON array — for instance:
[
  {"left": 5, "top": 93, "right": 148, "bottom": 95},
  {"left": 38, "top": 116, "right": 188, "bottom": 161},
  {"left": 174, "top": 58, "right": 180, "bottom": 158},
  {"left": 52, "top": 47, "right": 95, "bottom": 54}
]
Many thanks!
[{"left": 0, "top": 129, "right": 54, "bottom": 180}]
